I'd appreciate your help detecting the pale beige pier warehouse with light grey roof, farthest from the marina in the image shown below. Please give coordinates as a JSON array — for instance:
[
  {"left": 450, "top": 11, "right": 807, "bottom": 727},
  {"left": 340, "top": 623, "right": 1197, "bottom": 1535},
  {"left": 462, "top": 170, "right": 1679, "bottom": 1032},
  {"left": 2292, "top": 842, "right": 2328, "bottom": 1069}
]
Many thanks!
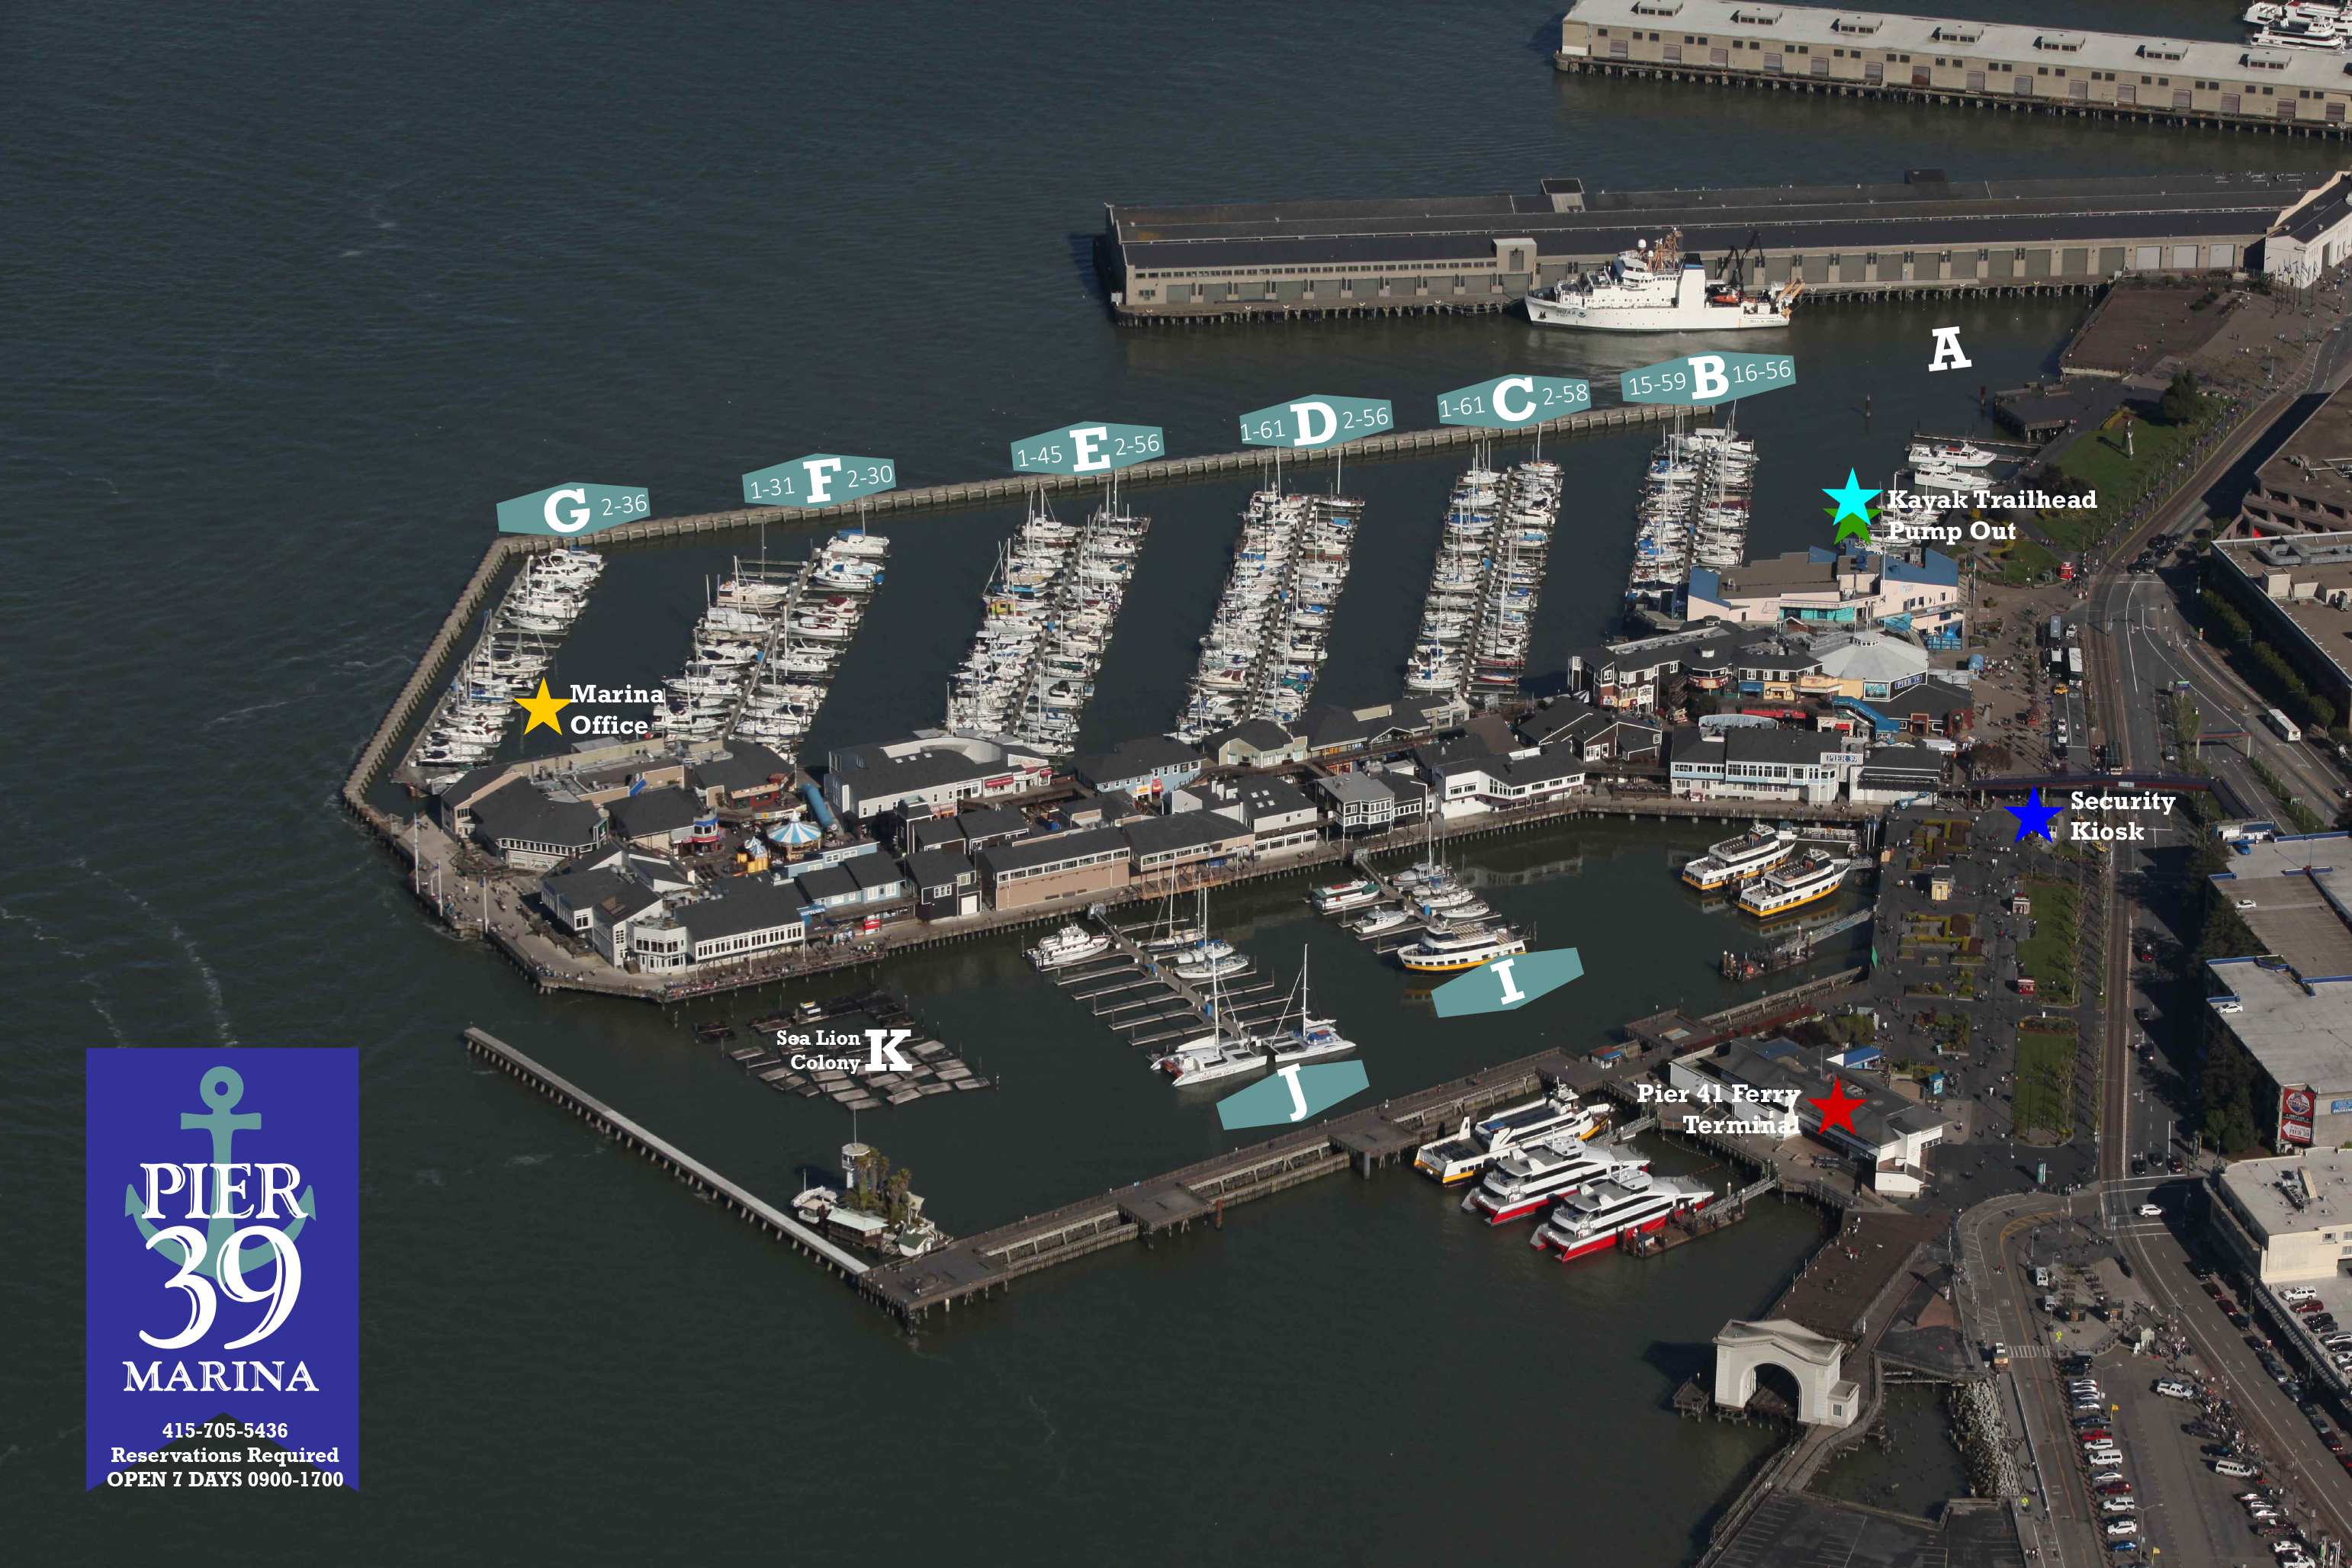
[{"left": 1552, "top": 0, "right": 2352, "bottom": 137}]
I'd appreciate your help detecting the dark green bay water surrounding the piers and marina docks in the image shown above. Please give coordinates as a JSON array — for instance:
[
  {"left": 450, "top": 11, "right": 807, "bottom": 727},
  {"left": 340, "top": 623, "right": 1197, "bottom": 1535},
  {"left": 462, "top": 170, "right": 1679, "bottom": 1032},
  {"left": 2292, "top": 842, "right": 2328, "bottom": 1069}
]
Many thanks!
[{"left": 0, "top": 0, "right": 2321, "bottom": 1566}]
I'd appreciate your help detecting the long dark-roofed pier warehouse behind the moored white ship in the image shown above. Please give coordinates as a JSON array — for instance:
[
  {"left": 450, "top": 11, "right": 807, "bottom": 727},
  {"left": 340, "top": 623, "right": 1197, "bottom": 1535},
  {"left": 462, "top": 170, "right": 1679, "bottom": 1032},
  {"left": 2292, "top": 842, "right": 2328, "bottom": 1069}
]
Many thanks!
[{"left": 1098, "top": 169, "right": 2352, "bottom": 322}]
